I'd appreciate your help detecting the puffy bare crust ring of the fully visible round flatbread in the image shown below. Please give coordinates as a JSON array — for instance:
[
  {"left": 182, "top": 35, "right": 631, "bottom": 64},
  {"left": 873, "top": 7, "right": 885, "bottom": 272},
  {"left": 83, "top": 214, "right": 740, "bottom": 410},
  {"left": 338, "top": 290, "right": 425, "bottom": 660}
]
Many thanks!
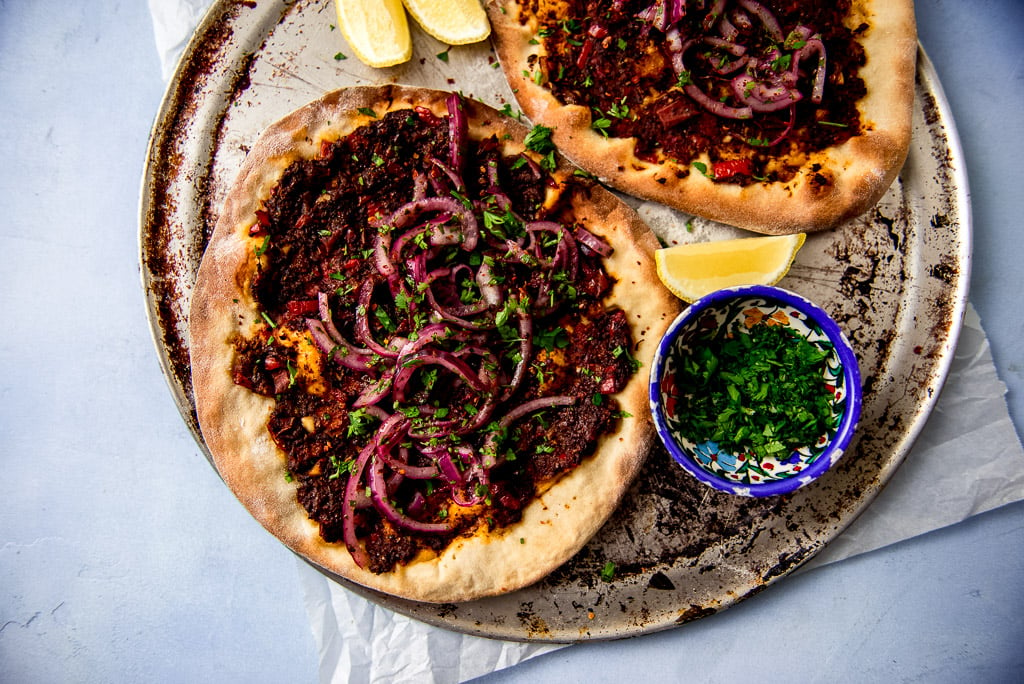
[{"left": 189, "top": 86, "right": 679, "bottom": 602}]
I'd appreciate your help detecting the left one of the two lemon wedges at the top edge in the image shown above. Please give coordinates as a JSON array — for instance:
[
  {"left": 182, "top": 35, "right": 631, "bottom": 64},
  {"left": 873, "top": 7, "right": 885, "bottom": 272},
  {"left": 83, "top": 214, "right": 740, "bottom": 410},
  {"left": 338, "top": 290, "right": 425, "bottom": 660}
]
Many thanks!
[{"left": 334, "top": 0, "right": 413, "bottom": 68}]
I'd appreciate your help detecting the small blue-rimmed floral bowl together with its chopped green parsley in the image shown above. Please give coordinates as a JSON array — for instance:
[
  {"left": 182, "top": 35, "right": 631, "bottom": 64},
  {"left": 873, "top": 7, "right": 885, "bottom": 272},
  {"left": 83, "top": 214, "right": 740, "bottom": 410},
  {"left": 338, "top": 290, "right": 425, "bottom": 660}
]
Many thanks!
[{"left": 650, "top": 286, "right": 861, "bottom": 497}]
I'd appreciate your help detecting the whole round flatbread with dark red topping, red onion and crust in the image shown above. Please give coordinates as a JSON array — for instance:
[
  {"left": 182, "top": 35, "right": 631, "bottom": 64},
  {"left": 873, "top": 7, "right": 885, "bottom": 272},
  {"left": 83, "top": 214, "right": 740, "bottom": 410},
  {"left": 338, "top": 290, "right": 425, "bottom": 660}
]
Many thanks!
[{"left": 189, "top": 86, "right": 679, "bottom": 602}]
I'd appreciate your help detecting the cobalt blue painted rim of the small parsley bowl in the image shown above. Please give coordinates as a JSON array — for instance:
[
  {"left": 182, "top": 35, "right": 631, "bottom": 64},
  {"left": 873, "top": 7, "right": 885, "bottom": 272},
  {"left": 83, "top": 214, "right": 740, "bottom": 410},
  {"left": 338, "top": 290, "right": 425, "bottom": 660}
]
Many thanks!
[{"left": 648, "top": 285, "right": 862, "bottom": 497}]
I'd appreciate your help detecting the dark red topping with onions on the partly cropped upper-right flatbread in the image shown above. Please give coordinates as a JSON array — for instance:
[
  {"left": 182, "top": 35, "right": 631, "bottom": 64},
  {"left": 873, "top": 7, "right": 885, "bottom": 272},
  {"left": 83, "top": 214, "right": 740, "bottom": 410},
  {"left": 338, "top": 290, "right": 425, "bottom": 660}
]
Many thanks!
[{"left": 521, "top": 0, "right": 867, "bottom": 184}]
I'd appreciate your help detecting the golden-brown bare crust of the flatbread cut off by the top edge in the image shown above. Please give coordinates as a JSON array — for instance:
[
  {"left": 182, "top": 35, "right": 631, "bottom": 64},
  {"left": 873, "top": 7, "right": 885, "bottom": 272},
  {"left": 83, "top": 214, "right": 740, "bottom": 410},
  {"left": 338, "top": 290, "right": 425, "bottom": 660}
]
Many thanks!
[{"left": 486, "top": 0, "right": 918, "bottom": 234}]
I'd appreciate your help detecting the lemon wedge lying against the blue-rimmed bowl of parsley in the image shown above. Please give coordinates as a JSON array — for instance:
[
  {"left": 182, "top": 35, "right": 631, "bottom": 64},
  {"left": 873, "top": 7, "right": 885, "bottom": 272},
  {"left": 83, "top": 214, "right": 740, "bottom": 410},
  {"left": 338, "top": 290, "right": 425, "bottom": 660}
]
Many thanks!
[{"left": 654, "top": 232, "right": 807, "bottom": 302}]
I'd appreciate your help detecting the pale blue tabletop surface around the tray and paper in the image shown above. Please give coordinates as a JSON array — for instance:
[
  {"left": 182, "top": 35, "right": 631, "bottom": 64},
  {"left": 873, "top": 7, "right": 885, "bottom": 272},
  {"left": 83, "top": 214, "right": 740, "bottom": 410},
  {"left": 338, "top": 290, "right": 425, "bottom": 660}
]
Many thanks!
[{"left": 0, "top": 0, "right": 1024, "bottom": 682}]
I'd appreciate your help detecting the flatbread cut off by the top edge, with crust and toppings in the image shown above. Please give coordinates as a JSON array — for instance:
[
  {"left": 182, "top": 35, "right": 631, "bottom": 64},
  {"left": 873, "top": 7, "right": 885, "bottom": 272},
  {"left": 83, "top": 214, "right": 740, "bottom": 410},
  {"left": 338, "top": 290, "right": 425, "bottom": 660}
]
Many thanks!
[{"left": 486, "top": 0, "right": 918, "bottom": 233}]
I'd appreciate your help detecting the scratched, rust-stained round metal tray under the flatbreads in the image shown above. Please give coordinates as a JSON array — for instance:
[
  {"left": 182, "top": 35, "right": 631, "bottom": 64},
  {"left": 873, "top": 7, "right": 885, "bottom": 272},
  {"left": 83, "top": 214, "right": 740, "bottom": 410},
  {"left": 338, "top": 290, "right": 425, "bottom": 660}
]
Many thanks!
[{"left": 140, "top": 0, "right": 971, "bottom": 642}]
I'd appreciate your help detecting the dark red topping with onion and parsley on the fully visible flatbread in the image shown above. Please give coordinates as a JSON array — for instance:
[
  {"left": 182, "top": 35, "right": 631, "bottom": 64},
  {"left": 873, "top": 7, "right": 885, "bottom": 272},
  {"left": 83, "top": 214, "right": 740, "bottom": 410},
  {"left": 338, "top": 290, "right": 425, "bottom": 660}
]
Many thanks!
[{"left": 232, "top": 96, "right": 636, "bottom": 572}]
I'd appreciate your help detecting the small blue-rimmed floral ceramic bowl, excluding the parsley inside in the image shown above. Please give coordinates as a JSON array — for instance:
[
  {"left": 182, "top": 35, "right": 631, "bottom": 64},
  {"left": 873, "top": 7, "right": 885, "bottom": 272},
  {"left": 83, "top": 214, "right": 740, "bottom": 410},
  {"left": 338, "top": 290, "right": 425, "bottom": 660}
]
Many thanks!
[{"left": 650, "top": 286, "right": 861, "bottom": 497}]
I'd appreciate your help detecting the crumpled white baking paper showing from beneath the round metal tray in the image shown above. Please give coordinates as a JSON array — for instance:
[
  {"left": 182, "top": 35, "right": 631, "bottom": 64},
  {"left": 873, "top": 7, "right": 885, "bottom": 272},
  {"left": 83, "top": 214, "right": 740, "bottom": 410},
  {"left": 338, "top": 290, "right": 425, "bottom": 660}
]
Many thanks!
[{"left": 148, "top": 6, "right": 1024, "bottom": 684}]
